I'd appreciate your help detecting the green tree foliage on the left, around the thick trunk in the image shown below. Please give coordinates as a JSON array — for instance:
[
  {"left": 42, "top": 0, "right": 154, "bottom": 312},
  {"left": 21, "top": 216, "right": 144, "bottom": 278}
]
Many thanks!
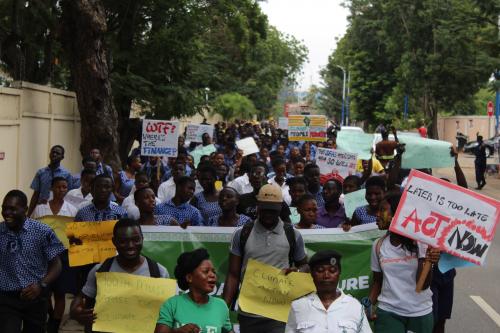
[{"left": 0, "top": 0, "right": 307, "bottom": 121}]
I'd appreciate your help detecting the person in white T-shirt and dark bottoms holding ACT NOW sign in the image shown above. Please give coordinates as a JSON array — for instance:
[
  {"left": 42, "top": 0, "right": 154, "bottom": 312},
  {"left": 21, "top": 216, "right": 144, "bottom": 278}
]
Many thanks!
[{"left": 362, "top": 198, "right": 439, "bottom": 333}]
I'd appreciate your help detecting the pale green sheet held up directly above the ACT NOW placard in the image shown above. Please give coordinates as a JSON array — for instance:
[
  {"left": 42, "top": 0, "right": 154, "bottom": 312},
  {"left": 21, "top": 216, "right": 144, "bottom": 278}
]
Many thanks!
[{"left": 398, "top": 134, "right": 455, "bottom": 169}]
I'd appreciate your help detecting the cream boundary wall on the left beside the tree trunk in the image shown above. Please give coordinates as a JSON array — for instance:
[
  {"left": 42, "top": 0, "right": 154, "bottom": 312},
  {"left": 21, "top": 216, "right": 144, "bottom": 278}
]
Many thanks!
[{"left": 0, "top": 82, "right": 82, "bottom": 200}]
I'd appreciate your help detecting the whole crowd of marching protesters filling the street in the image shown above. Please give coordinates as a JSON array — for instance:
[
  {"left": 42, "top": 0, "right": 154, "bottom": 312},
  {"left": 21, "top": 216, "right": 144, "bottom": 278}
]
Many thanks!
[{"left": 0, "top": 121, "right": 474, "bottom": 333}]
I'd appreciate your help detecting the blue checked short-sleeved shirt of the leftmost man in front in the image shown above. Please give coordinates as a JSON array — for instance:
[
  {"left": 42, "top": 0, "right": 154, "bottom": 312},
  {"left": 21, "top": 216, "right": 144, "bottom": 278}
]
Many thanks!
[{"left": 0, "top": 218, "right": 64, "bottom": 291}]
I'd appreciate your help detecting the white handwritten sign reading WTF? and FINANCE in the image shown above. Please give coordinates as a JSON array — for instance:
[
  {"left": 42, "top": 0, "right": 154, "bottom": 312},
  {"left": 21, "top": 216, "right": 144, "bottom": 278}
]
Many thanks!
[{"left": 141, "top": 119, "right": 179, "bottom": 157}]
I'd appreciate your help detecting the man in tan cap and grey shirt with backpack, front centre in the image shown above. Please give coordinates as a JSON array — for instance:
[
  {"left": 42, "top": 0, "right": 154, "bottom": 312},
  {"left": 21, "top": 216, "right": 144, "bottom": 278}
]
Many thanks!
[{"left": 223, "top": 184, "right": 307, "bottom": 333}]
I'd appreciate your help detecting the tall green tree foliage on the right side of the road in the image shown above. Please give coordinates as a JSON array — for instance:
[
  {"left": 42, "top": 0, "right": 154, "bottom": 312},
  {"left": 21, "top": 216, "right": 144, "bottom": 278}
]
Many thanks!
[{"left": 322, "top": 0, "right": 500, "bottom": 134}]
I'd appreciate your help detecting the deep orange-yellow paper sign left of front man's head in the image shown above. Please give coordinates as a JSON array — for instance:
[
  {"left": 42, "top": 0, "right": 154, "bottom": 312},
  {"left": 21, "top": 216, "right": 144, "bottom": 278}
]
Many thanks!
[{"left": 66, "top": 221, "right": 116, "bottom": 267}]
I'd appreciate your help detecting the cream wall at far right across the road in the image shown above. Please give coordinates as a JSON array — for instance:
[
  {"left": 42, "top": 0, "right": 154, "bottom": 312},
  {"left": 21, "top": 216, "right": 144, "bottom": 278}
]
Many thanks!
[{"left": 438, "top": 116, "right": 495, "bottom": 145}]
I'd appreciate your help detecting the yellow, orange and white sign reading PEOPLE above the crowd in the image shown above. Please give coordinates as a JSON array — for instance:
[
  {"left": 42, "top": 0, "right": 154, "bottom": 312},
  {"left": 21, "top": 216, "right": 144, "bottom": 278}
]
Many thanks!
[{"left": 288, "top": 115, "right": 327, "bottom": 141}]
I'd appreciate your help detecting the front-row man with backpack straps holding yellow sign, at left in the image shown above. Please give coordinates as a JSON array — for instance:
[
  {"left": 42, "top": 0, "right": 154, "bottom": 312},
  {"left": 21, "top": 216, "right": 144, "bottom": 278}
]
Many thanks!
[{"left": 70, "top": 219, "right": 169, "bottom": 332}]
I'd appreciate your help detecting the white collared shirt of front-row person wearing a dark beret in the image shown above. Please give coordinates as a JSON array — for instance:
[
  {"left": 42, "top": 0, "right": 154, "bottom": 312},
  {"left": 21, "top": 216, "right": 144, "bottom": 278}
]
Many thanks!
[{"left": 285, "top": 290, "right": 372, "bottom": 333}]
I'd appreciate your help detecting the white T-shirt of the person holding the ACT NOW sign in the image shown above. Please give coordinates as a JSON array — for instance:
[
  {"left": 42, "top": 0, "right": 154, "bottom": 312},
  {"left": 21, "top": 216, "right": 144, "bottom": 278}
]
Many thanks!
[{"left": 371, "top": 236, "right": 432, "bottom": 317}]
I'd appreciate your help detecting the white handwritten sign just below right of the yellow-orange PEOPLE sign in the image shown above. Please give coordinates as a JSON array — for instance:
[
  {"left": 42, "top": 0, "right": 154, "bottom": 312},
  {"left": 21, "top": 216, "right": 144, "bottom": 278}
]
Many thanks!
[{"left": 316, "top": 148, "right": 358, "bottom": 178}]
